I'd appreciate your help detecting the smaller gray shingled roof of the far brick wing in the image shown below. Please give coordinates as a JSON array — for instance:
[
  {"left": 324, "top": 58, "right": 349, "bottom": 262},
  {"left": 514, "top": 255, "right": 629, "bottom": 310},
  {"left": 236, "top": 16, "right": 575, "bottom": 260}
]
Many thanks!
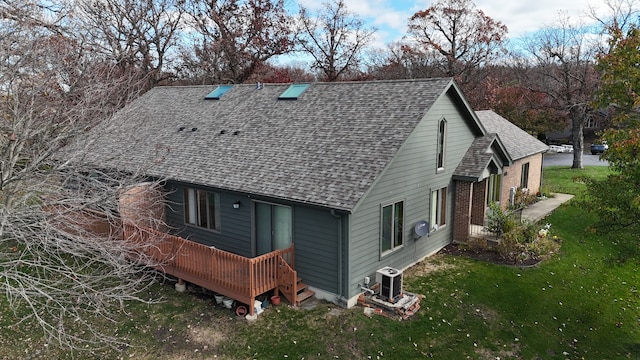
[{"left": 476, "top": 110, "right": 549, "bottom": 160}]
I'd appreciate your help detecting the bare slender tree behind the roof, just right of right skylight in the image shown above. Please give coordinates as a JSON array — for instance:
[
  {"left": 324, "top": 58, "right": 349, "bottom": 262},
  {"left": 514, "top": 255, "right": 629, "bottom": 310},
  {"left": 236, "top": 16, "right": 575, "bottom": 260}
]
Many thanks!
[{"left": 298, "top": 0, "right": 376, "bottom": 81}]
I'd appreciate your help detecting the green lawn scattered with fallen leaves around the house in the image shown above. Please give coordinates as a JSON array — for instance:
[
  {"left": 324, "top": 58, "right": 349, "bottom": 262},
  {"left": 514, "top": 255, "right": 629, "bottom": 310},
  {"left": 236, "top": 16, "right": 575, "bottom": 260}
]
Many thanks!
[{"left": 0, "top": 167, "right": 640, "bottom": 359}]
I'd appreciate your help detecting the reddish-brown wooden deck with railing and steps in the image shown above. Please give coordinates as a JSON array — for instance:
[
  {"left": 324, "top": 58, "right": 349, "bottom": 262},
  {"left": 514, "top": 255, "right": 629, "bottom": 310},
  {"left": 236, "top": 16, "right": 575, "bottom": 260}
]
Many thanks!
[{"left": 123, "top": 224, "right": 304, "bottom": 315}]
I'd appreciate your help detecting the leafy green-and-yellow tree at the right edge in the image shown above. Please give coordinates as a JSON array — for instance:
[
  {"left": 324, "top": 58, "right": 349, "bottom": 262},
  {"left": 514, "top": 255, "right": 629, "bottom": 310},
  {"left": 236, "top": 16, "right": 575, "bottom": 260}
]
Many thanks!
[{"left": 587, "top": 25, "right": 640, "bottom": 260}]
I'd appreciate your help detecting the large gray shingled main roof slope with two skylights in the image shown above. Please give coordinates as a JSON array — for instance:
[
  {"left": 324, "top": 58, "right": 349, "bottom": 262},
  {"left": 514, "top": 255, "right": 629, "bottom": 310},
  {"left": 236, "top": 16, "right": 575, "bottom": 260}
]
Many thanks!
[{"left": 84, "top": 78, "right": 453, "bottom": 210}]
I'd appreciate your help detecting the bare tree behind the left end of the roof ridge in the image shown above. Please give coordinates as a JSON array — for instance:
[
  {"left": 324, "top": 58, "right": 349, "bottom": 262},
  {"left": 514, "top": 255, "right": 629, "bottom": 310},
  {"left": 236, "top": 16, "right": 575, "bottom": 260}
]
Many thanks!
[{"left": 74, "top": 0, "right": 184, "bottom": 87}]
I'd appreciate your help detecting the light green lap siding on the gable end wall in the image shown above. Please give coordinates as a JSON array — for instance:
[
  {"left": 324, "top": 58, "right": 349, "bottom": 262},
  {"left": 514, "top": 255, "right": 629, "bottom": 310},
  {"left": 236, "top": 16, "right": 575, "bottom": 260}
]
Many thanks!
[{"left": 347, "top": 92, "right": 474, "bottom": 297}]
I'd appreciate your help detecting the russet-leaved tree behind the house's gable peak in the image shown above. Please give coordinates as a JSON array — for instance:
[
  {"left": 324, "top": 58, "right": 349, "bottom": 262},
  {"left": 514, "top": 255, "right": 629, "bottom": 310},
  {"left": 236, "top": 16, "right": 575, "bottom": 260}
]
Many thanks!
[{"left": 409, "top": 0, "right": 508, "bottom": 97}]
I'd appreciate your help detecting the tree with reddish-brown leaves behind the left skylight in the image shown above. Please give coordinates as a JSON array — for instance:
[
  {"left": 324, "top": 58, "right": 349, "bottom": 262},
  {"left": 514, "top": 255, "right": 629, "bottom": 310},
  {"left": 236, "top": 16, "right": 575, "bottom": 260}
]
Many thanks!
[{"left": 181, "top": 0, "right": 295, "bottom": 83}]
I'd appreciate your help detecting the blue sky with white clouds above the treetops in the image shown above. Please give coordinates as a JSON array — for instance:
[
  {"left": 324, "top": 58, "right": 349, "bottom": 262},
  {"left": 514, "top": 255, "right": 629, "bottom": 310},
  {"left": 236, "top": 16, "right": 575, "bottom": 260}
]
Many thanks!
[{"left": 294, "top": 0, "right": 602, "bottom": 47}]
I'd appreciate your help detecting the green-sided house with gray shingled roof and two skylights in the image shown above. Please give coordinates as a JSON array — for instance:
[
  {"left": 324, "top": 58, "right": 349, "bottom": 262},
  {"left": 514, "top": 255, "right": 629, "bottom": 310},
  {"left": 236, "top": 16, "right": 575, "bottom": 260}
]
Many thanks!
[{"left": 81, "top": 78, "right": 539, "bottom": 306}]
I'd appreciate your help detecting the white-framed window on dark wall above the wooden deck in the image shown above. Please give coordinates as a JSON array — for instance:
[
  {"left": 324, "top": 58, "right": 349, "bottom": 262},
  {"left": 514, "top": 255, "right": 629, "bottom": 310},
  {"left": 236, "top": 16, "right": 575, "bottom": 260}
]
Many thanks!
[{"left": 184, "top": 188, "right": 220, "bottom": 230}]
